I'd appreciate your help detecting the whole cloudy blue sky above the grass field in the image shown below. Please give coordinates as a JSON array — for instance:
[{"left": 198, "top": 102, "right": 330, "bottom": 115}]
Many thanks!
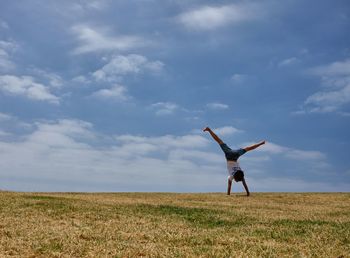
[{"left": 0, "top": 0, "right": 350, "bottom": 192}]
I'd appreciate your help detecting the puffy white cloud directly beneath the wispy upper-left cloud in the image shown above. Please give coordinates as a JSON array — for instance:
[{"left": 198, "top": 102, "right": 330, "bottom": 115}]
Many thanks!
[{"left": 93, "top": 54, "right": 164, "bottom": 82}]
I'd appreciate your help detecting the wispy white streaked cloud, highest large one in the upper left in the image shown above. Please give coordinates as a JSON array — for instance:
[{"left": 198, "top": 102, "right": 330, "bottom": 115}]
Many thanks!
[{"left": 72, "top": 25, "right": 148, "bottom": 54}]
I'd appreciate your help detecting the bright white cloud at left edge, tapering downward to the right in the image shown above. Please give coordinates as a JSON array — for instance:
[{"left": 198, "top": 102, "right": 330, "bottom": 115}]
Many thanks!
[{"left": 0, "top": 75, "right": 59, "bottom": 104}]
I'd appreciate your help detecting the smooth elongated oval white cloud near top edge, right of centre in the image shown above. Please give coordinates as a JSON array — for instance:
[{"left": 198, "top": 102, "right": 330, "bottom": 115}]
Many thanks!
[{"left": 177, "top": 4, "right": 260, "bottom": 31}]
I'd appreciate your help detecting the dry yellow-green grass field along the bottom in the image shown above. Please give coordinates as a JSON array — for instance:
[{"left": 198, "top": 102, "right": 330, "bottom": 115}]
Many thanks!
[{"left": 0, "top": 192, "right": 350, "bottom": 257}]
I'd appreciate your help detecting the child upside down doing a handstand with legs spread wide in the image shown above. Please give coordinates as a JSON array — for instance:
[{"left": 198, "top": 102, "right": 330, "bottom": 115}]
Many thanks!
[{"left": 203, "top": 127, "right": 265, "bottom": 196}]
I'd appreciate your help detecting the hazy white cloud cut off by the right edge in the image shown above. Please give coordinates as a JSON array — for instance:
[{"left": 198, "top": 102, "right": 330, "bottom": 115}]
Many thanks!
[{"left": 299, "top": 60, "right": 350, "bottom": 114}]
